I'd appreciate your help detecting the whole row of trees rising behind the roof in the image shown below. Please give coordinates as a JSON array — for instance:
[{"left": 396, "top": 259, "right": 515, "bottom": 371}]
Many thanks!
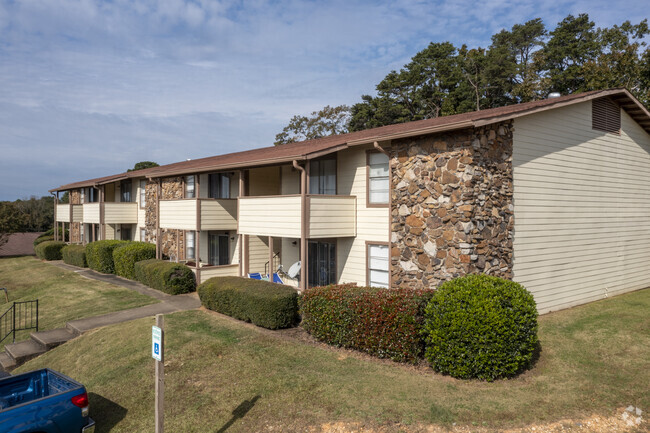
[{"left": 275, "top": 14, "right": 650, "bottom": 145}]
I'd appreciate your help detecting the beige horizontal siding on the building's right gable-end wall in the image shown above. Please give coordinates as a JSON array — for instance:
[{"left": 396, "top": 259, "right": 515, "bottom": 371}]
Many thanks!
[{"left": 513, "top": 102, "right": 650, "bottom": 313}]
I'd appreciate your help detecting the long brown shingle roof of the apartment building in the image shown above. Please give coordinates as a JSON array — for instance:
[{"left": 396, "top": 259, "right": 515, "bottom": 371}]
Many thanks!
[{"left": 53, "top": 89, "right": 650, "bottom": 191}]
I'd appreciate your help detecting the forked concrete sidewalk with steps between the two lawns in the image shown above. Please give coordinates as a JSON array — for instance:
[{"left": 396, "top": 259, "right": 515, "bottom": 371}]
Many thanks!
[{"left": 0, "top": 261, "right": 201, "bottom": 371}]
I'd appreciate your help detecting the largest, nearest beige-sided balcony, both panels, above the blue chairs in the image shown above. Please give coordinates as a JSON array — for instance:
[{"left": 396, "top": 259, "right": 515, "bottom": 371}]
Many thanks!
[{"left": 239, "top": 195, "right": 357, "bottom": 239}]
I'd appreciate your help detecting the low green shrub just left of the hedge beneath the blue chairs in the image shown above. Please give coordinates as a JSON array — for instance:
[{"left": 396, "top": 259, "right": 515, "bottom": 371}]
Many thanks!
[{"left": 134, "top": 259, "right": 196, "bottom": 295}]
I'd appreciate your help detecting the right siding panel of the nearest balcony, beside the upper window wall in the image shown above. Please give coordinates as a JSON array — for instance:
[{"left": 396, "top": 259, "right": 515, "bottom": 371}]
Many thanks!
[{"left": 309, "top": 195, "right": 357, "bottom": 239}]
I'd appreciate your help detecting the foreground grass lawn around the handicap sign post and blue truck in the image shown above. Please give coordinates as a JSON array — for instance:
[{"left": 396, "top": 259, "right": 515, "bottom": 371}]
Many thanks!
[{"left": 18, "top": 289, "right": 650, "bottom": 433}]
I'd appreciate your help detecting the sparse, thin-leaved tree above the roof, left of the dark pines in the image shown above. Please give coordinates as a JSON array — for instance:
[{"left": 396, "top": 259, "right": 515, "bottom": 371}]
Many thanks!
[{"left": 275, "top": 105, "right": 350, "bottom": 146}]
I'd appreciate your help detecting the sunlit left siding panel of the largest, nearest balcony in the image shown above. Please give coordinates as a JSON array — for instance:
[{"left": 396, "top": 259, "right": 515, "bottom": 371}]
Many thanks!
[{"left": 239, "top": 196, "right": 300, "bottom": 236}]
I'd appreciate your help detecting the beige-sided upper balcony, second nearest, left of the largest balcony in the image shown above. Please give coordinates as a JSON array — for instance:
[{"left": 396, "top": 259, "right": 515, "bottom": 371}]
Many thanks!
[{"left": 160, "top": 198, "right": 237, "bottom": 230}]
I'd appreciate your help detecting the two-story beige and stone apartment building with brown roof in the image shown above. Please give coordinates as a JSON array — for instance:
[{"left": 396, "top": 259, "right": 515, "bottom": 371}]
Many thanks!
[{"left": 52, "top": 89, "right": 650, "bottom": 313}]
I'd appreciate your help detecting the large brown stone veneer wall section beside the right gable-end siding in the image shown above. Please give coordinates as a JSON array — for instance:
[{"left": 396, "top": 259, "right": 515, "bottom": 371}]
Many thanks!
[{"left": 391, "top": 121, "right": 514, "bottom": 288}]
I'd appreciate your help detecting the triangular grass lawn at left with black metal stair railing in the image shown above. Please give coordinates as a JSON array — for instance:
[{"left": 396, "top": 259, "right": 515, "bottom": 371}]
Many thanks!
[{"left": 0, "top": 257, "right": 158, "bottom": 350}]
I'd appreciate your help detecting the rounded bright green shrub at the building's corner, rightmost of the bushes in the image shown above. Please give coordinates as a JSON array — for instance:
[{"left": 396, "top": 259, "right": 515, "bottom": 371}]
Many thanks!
[{"left": 424, "top": 275, "right": 538, "bottom": 381}]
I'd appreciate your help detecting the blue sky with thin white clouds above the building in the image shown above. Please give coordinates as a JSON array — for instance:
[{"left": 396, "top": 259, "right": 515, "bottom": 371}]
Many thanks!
[{"left": 0, "top": 0, "right": 648, "bottom": 200}]
